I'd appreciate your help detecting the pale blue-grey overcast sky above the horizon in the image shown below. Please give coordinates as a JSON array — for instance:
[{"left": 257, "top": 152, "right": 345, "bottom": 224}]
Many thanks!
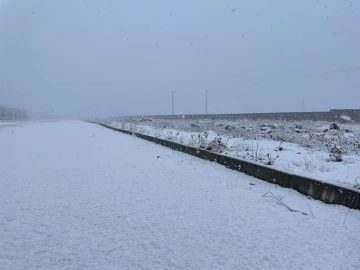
[{"left": 0, "top": 0, "right": 360, "bottom": 117}]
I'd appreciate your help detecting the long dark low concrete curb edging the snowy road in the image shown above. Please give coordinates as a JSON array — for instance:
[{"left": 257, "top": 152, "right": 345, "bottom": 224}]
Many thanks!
[{"left": 96, "top": 123, "right": 360, "bottom": 210}]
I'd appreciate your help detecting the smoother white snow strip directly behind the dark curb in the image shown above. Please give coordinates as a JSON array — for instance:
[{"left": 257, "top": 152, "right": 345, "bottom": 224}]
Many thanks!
[{"left": 110, "top": 122, "right": 360, "bottom": 191}]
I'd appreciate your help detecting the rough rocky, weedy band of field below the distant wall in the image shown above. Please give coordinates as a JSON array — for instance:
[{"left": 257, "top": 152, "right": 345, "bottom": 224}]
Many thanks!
[{"left": 115, "top": 117, "right": 360, "bottom": 156}]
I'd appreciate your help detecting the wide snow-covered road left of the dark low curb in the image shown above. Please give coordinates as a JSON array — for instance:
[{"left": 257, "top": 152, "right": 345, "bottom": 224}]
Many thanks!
[{"left": 0, "top": 121, "right": 360, "bottom": 270}]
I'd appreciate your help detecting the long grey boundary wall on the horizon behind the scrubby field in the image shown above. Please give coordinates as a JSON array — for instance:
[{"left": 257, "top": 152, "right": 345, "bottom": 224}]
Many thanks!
[{"left": 109, "top": 110, "right": 360, "bottom": 122}]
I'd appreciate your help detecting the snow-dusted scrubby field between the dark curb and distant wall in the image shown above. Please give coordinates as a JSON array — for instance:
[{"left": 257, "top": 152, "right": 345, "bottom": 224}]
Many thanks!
[{"left": 105, "top": 118, "right": 360, "bottom": 190}]
